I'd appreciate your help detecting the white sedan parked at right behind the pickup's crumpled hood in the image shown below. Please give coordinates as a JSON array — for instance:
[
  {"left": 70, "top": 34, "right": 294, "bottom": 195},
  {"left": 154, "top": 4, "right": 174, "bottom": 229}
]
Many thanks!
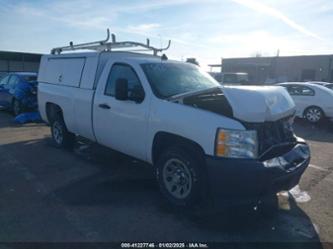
[{"left": 278, "top": 82, "right": 333, "bottom": 123}]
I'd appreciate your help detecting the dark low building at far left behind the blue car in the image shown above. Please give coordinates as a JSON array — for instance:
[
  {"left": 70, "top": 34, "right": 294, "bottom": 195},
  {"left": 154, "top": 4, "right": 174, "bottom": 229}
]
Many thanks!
[{"left": 0, "top": 51, "right": 42, "bottom": 77}]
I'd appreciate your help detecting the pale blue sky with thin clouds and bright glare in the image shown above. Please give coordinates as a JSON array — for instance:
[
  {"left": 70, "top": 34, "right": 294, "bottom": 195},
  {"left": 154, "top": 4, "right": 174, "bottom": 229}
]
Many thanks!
[{"left": 0, "top": 0, "right": 333, "bottom": 66}]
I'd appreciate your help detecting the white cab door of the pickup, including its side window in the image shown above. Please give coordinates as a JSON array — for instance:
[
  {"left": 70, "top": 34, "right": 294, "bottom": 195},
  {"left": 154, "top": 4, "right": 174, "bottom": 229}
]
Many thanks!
[{"left": 93, "top": 63, "right": 149, "bottom": 160}]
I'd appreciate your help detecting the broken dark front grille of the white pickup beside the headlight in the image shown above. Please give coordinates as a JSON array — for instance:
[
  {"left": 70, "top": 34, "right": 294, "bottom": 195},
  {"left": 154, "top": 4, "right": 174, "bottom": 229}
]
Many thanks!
[{"left": 244, "top": 118, "right": 296, "bottom": 155}]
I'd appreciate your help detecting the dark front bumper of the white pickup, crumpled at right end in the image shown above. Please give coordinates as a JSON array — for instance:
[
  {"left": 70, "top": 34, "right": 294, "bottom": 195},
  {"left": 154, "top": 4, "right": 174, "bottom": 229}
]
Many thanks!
[{"left": 206, "top": 140, "right": 310, "bottom": 205}]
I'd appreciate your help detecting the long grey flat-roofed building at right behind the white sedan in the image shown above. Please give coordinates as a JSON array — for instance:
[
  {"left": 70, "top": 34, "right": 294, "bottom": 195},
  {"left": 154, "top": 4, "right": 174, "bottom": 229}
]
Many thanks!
[{"left": 220, "top": 55, "right": 333, "bottom": 84}]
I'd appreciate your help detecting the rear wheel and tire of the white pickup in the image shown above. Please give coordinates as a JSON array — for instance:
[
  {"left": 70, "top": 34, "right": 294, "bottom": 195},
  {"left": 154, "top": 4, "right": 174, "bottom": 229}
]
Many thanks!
[{"left": 51, "top": 117, "right": 75, "bottom": 149}]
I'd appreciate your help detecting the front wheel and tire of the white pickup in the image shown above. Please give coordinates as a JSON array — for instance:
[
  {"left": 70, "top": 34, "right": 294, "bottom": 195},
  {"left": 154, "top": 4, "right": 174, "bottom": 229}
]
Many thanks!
[{"left": 156, "top": 147, "right": 206, "bottom": 207}]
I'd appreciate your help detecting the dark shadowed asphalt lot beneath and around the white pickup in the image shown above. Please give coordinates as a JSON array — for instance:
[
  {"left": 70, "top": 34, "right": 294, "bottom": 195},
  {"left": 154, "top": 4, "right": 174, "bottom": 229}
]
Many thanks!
[{"left": 0, "top": 112, "right": 333, "bottom": 248}]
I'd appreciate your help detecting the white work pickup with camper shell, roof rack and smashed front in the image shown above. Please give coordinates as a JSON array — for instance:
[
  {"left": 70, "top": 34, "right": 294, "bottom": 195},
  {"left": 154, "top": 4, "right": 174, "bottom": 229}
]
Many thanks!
[{"left": 38, "top": 34, "right": 310, "bottom": 207}]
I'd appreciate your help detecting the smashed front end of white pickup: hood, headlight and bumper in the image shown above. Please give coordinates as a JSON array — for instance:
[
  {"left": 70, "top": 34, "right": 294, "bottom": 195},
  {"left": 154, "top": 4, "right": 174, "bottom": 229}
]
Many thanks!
[{"left": 169, "top": 86, "right": 310, "bottom": 208}]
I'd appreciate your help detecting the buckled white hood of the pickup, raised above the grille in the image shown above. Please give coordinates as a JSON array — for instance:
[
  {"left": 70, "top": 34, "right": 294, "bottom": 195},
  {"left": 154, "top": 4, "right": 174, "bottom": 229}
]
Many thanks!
[{"left": 221, "top": 86, "right": 296, "bottom": 123}]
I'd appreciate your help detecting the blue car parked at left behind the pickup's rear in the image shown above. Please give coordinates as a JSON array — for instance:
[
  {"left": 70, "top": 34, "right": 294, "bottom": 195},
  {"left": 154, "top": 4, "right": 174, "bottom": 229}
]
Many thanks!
[{"left": 0, "top": 72, "right": 37, "bottom": 116}]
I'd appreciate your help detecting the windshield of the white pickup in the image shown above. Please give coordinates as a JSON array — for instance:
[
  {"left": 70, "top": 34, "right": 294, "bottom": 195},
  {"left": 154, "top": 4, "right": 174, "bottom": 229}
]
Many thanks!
[{"left": 141, "top": 62, "right": 220, "bottom": 98}]
